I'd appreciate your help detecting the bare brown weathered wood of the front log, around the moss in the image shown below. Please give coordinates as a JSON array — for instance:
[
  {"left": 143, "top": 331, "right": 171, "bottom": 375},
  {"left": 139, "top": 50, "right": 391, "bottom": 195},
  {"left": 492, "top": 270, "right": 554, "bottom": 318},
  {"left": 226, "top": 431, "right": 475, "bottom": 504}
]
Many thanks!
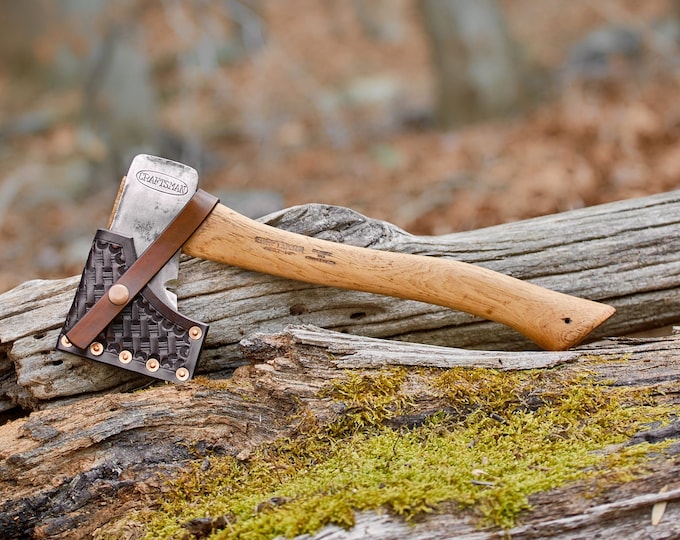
[{"left": 0, "top": 326, "right": 680, "bottom": 539}]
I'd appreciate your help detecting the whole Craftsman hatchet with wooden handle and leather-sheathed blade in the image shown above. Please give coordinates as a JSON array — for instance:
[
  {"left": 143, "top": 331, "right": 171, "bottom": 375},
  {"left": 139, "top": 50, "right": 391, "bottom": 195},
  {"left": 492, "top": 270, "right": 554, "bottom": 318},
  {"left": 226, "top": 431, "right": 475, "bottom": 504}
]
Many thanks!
[{"left": 57, "top": 155, "right": 615, "bottom": 382}]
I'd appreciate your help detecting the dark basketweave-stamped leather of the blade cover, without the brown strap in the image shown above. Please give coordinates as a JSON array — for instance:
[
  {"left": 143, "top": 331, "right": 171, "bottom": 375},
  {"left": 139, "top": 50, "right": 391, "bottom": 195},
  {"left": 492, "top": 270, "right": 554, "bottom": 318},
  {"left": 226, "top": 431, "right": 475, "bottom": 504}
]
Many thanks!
[{"left": 57, "top": 229, "right": 208, "bottom": 382}]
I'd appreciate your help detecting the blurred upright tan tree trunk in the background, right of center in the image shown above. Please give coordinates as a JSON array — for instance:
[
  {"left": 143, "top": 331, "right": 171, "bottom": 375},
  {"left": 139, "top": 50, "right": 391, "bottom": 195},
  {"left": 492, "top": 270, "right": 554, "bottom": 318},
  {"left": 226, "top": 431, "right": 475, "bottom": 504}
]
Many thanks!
[{"left": 418, "top": 0, "right": 524, "bottom": 128}]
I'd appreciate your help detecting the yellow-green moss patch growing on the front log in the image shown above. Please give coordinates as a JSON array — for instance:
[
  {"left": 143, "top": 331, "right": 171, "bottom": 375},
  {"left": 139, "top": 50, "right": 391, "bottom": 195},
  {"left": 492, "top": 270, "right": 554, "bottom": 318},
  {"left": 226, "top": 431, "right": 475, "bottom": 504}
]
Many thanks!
[{"left": 138, "top": 369, "right": 670, "bottom": 539}]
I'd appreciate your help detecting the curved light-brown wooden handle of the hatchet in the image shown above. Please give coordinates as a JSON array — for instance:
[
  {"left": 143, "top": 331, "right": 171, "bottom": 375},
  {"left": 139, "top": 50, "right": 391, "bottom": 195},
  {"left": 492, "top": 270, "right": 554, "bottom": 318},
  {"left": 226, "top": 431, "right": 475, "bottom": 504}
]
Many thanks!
[{"left": 182, "top": 204, "right": 615, "bottom": 350}]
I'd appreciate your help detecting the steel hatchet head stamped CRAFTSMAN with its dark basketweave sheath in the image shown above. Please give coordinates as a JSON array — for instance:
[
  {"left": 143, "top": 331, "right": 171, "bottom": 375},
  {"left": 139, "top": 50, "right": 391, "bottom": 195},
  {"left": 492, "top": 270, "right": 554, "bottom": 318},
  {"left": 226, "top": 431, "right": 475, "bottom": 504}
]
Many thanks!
[{"left": 57, "top": 155, "right": 214, "bottom": 382}]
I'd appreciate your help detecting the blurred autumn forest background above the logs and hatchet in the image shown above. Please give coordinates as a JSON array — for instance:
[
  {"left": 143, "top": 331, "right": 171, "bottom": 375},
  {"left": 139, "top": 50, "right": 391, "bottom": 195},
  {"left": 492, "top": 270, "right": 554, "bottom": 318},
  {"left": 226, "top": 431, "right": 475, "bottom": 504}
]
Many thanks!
[{"left": 0, "top": 0, "right": 680, "bottom": 291}]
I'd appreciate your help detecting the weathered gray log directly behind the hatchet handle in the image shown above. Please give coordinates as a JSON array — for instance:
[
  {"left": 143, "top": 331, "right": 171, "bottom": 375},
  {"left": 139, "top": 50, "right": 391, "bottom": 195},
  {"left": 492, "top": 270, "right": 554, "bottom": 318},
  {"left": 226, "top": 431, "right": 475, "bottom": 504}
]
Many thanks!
[{"left": 0, "top": 191, "right": 680, "bottom": 412}]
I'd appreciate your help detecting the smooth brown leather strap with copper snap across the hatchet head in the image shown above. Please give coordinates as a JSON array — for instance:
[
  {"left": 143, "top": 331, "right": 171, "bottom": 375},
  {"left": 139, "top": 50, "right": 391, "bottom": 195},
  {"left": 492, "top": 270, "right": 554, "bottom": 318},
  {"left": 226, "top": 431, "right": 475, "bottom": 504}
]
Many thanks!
[{"left": 66, "top": 189, "right": 219, "bottom": 349}]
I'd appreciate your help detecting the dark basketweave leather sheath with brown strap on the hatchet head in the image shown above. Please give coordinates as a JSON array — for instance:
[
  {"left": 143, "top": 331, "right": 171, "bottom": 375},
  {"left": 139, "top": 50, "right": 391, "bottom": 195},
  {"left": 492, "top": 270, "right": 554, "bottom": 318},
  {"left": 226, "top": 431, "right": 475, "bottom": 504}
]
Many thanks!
[{"left": 57, "top": 190, "right": 218, "bottom": 382}]
